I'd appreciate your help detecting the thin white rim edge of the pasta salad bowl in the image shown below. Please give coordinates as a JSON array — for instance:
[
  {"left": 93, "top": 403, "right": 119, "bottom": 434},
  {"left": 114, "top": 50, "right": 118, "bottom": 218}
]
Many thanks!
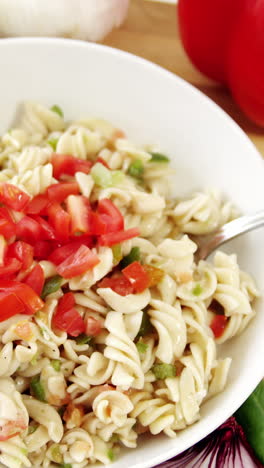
[{"left": 0, "top": 37, "right": 263, "bottom": 468}]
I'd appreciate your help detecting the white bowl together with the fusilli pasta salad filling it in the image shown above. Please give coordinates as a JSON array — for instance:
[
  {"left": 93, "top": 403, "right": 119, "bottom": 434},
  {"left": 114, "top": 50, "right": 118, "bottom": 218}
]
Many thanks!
[{"left": 0, "top": 40, "right": 264, "bottom": 468}]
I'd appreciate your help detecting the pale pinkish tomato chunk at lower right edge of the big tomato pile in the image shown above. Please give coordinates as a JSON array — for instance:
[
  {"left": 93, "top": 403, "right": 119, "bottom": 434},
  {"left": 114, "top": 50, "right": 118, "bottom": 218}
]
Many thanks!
[{"left": 57, "top": 245, "right": 100, "bottom": 278}]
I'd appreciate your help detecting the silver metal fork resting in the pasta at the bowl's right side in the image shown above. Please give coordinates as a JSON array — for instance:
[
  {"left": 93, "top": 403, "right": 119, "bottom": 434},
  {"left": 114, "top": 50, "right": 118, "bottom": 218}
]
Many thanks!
[{"left": 189, "top": 210, "right": 264, "bottom": 261}]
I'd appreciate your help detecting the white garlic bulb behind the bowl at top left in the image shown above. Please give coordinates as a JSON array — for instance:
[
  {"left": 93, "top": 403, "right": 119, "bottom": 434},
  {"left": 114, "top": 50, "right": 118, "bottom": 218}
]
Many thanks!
[{"left": 0, "top": 0, "right": 129, "bottom": 41}]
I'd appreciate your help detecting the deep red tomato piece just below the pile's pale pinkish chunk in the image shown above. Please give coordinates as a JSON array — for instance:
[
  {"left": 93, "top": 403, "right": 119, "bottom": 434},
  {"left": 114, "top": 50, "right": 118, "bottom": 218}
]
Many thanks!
[{"left": 52, "top": 293, "right": 85, "bottom": 336}]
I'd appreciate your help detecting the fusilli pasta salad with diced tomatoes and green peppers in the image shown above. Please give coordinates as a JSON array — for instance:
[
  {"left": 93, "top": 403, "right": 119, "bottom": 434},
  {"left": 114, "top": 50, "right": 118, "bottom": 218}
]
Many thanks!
[{"left": 0, "top": 102, "right": 258, "bottom": 468}]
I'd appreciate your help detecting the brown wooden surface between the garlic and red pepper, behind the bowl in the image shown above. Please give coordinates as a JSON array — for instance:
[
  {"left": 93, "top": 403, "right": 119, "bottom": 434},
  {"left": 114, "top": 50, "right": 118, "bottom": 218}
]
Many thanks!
[{"left": 104, "top": 0, "right": 264, "bottom": 156}]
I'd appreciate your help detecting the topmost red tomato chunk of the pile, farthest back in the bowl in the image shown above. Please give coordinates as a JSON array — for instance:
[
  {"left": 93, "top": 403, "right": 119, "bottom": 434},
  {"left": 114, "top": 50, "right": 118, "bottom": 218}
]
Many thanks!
[{"left": 51, "top": 153, "right": 92, "bottom": 179}]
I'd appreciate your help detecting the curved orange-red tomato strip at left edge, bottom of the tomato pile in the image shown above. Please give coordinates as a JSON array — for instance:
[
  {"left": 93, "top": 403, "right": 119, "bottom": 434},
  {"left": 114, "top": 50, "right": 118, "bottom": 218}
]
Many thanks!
[{"left": 0, "top": 279, "right": 44, "bottom": 314}]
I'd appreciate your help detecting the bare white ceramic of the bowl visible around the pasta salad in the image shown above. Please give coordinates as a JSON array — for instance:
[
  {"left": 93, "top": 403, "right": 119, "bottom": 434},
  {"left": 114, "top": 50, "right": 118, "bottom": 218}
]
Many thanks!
[{"left": 0, "top": 39, "right": 264, "bottom": 468}]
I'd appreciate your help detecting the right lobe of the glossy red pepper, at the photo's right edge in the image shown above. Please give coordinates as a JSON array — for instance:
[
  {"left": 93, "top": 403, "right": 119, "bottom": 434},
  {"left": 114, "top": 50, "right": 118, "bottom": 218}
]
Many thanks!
[{"left": 227, "top": 0, "right": 264, "bottom": 127}]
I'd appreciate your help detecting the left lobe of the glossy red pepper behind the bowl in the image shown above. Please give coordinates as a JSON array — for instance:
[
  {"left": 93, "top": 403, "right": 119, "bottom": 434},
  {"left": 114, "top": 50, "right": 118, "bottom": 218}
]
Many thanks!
[{"left": 178, "top": 0, "right": 243, "bottom": 83}]
